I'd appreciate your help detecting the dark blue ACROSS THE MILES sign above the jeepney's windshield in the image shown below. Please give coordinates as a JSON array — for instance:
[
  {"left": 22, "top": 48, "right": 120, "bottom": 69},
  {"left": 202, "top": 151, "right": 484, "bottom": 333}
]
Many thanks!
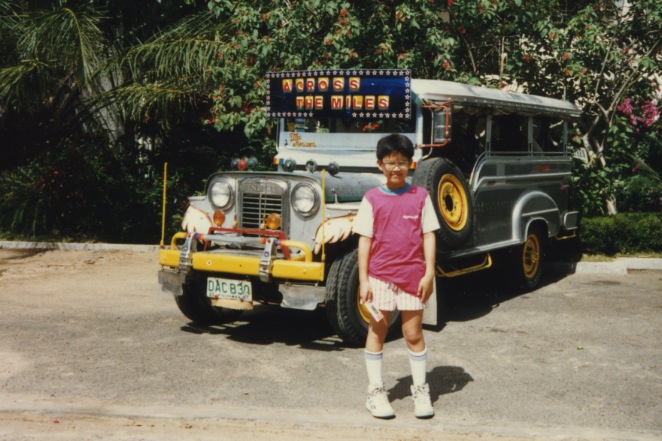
[{"left": 266, "top": 69, "right": 411, "bottom": 119}]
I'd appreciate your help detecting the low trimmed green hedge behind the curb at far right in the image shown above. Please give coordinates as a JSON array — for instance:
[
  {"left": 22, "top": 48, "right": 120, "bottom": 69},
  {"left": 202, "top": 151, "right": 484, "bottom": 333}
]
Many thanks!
[{"left": 579, "top": 213, "right": 662, "bottom": 255}]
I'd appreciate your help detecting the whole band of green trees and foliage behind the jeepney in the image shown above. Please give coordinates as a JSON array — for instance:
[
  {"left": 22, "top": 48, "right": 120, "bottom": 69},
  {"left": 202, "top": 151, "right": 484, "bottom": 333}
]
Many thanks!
[{"left": 0, "top": 0, "right": 662, "bottom": 242}]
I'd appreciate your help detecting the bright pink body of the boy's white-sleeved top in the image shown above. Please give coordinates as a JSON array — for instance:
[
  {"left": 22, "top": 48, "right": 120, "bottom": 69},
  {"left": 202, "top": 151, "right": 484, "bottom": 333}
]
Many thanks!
[{"left": 365, "top": 185, "right": 428, "bottom": 295}]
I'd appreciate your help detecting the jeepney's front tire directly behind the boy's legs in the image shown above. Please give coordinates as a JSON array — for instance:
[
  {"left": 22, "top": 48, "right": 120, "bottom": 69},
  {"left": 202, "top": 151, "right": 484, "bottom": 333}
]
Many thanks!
[{"left": 326, "top": 249, "right": 400, "bottom": 346}]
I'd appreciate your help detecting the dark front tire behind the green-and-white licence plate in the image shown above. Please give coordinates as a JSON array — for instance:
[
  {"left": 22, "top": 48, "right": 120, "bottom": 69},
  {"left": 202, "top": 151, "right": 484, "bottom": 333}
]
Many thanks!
[{"left": 175, "top": 276, "right": 241, "bottom": 326}]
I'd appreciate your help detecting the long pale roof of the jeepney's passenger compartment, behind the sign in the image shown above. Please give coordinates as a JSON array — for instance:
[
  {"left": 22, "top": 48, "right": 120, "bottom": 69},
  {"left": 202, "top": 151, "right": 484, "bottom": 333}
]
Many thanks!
[{"left": 411, "top": 79, "right": 581, "bottom": 119}]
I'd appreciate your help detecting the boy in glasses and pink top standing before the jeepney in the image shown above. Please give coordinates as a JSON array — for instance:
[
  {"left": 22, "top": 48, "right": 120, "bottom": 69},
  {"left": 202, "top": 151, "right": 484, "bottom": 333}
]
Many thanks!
[{"left": 354, "top": 134, "right": 440, "bottom": 418}]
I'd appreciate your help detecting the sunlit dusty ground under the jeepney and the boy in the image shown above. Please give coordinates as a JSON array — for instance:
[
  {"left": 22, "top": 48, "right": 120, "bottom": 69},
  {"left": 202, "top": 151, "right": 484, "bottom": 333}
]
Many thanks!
[{"left": 0, "top": 249, "right": 662, "bottom": 441}]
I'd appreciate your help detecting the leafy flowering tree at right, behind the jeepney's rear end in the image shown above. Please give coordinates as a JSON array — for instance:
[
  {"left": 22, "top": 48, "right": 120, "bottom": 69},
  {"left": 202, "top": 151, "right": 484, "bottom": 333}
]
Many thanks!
[{"left": 530, "top": 0, "right": 662, "bottom": 214}]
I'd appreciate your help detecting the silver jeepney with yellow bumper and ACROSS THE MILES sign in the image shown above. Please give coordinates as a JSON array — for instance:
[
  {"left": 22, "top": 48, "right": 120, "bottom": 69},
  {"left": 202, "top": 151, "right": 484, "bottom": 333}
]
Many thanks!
[{"left": 159, "top": 70, "right": 580, "bottom": 344}]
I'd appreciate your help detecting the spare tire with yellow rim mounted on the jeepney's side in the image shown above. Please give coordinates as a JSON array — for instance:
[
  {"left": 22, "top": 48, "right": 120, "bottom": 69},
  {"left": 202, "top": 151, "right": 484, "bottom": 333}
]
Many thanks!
[{"left": 413, "top": 158, "right": 473, "bottom": 251}]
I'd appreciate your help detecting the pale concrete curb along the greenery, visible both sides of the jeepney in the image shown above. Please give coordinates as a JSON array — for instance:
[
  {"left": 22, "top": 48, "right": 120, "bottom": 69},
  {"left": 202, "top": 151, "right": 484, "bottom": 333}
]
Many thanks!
[{"left": 0, "top": 241, "right": 662, "bottom": 274}]
